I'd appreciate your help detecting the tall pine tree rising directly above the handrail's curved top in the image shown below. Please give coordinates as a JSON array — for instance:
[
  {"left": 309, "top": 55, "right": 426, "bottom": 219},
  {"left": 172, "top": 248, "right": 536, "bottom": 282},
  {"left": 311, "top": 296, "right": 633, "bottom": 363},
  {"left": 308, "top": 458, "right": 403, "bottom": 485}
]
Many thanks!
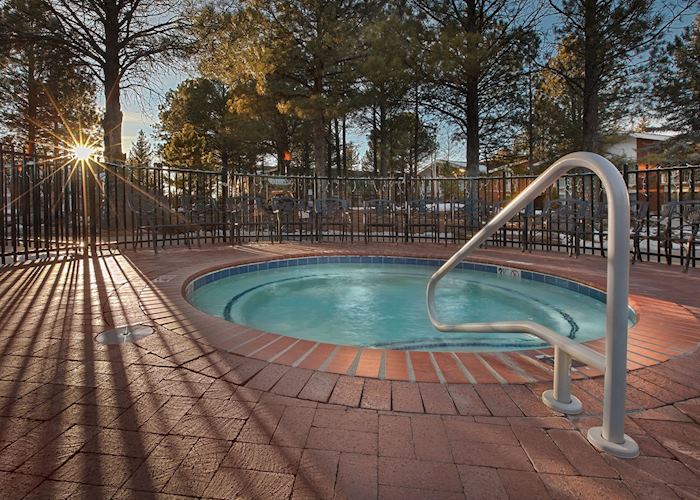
[{"left": 547, "top": 0, "right": 694, "bottom": 152}]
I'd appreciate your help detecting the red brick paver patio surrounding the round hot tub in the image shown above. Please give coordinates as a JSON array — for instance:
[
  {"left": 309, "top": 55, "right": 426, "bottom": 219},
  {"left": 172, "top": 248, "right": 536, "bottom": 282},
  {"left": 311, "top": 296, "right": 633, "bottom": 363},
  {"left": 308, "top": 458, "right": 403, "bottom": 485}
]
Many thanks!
[{"left": 0, "top": 244, "right": 700, "bottom": 500}]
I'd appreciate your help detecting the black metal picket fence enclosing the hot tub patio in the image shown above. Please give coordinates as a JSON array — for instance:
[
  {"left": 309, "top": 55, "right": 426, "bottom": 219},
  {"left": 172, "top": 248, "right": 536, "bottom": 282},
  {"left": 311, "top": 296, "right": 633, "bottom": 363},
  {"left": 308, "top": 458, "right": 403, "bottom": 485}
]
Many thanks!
[{"left": 0, "top": 148, "right": 700, "bottom": 266}]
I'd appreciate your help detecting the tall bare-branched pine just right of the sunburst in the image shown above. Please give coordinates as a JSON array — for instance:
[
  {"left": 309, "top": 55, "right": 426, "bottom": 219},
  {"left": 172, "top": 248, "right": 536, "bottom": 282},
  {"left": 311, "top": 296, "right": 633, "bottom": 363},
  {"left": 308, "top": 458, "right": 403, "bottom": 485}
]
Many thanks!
[{"left": 3, "top": 0, "right": 189, "bottom": 161}]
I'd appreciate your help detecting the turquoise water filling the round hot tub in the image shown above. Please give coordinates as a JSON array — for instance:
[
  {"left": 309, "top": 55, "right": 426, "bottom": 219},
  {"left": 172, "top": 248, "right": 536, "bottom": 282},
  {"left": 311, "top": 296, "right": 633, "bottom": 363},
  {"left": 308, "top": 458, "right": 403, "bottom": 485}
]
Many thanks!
[{"left": 188, "top": 263, "right": 624, "bottom": 351}]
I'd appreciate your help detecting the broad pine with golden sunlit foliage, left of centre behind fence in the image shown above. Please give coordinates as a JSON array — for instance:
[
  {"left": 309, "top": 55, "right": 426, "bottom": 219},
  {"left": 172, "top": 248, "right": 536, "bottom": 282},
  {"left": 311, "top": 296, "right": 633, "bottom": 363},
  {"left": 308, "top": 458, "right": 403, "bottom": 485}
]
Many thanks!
[{"left": 194, "top": 0, "right": 372, "bottom": 176}]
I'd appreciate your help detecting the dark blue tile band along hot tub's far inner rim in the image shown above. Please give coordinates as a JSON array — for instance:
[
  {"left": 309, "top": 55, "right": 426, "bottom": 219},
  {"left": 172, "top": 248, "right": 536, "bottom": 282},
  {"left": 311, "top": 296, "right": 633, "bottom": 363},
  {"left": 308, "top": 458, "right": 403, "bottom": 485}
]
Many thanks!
[{"left": 185, "top": 255, "right": 637, "bottom": 322}]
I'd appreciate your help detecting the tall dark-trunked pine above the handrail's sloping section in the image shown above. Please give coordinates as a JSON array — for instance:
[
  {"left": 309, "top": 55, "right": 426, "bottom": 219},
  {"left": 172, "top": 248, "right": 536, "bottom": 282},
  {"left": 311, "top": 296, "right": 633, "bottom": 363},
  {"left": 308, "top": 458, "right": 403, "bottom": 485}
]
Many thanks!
[{"left": 414, "top": 0, "right": 538, "bottom": 175}]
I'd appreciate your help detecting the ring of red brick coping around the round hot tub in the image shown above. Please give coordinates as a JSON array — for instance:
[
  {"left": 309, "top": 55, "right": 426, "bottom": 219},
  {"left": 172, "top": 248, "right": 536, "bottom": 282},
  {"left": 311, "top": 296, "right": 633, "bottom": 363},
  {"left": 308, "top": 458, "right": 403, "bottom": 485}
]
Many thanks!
[{"left": 140, "top": 247, "right": 700, "bottom": 384}]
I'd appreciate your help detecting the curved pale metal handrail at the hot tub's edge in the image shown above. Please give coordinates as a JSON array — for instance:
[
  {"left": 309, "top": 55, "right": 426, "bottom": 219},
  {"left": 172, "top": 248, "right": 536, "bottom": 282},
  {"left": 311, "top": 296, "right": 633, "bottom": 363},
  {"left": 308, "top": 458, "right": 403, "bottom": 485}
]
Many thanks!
[{"left": 426, "top": 152, "right": 639, "bottom": 458}]
